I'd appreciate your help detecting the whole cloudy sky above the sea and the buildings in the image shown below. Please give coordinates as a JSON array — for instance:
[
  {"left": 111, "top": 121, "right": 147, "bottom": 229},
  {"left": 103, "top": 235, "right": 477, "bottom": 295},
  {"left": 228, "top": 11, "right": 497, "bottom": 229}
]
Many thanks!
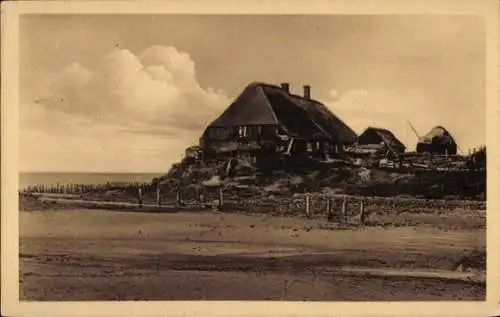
[{"left": 19, "top": 15, "right": 486, "bottom": 173}]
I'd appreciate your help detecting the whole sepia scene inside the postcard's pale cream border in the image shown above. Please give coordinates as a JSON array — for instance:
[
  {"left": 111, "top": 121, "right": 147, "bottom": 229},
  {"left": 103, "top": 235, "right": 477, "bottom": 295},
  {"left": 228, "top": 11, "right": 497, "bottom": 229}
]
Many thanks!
[{"left": 2, "top": 1, "right": 498, "bottom": 314}]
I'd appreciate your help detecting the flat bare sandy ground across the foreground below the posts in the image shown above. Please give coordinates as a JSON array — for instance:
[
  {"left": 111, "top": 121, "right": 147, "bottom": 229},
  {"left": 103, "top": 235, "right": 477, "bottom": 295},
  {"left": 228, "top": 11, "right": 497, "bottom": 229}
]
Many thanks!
[{"left": 19, "top": 209, "right": 486, "bottom": 301}]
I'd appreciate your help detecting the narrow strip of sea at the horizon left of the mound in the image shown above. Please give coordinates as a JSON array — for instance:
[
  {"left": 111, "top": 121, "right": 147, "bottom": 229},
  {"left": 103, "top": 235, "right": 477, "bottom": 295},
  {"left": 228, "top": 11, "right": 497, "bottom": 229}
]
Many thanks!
[{"left": 19, "top": 172, "right": 162, "bottom": 189}]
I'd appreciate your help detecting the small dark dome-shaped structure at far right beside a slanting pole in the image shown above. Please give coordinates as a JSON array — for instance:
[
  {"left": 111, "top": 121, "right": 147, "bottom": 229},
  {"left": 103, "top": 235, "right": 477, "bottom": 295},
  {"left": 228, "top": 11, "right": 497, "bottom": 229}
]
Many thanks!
[{"left": 417, "top": 126, "right": 458, "bottom": 155}]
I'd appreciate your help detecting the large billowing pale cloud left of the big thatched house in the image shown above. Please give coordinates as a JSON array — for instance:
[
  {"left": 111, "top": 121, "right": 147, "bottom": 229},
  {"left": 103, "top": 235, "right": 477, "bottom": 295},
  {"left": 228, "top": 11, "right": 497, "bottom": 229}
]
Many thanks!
[{"left": 32, "top": 46, "right": 230, "bottom": 135}]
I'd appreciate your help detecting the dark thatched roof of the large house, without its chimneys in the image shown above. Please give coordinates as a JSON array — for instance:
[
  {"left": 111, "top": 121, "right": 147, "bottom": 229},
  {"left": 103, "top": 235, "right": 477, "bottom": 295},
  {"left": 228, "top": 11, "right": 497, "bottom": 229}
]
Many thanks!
[{"left": 205, "top": 82, "right": 357, "bottom": 143}]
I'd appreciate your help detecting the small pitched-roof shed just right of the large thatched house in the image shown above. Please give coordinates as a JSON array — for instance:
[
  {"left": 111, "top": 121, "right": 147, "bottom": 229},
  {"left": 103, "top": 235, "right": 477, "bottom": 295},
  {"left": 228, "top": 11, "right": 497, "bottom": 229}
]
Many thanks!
[{"left": 356, "top": 127, "right": 406, "bottom": 156}]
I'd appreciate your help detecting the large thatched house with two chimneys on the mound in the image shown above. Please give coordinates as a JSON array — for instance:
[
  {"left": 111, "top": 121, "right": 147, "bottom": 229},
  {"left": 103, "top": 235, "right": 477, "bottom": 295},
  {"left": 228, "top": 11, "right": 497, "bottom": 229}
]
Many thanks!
[{"left": 200, "top": 83, "right": 357, "bottom": 157}]
